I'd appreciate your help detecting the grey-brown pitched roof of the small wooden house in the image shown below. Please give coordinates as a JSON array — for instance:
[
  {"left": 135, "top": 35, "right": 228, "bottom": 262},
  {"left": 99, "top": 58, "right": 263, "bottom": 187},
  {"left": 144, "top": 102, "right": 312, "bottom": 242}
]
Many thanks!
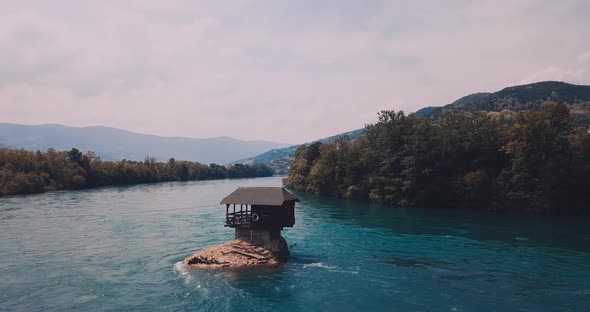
[{"left": 221, "top": 187, "right": 299, "bottom": 206}]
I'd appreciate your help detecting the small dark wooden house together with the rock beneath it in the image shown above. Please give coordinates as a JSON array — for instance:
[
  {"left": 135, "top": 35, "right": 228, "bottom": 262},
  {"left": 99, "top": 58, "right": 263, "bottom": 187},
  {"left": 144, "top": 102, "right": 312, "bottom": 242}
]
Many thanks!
[{"left": 183, "top": 187, "right": 299, "bottom": 269}]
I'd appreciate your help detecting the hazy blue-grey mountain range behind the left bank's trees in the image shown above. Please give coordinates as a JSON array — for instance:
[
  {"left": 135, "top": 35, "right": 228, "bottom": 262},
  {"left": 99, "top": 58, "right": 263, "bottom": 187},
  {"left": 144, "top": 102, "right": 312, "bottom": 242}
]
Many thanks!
[{"left": 0, "top": 123, "right": 287, "bottom": 164}]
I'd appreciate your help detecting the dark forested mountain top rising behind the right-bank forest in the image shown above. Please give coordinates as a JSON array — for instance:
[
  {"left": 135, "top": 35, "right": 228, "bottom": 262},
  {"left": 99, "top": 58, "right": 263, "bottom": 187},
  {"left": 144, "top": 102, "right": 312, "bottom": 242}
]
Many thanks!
[{"left": 415, "top": 81, "right": 590, "bottom": 126}]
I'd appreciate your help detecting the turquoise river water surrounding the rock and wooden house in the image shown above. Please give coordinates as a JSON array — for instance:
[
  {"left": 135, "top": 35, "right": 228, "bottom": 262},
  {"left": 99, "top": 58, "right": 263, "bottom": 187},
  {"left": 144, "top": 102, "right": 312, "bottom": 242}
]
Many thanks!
[{"left": 0, "top": 178, "right": 590, "bottom": 311}]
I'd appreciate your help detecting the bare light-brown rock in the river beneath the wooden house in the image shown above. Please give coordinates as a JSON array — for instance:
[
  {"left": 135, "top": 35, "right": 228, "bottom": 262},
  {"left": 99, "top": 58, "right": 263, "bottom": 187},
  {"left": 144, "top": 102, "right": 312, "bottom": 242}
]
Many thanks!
[{"left": 183, "top": 237, "right": 290, "bottom": 269}]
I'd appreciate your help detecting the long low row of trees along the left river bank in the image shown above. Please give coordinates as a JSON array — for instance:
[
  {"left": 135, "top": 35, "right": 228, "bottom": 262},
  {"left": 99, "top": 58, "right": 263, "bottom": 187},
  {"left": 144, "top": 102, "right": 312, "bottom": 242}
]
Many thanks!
[{"left": 0, "top": 148, "right": 273, "bottom": 196}]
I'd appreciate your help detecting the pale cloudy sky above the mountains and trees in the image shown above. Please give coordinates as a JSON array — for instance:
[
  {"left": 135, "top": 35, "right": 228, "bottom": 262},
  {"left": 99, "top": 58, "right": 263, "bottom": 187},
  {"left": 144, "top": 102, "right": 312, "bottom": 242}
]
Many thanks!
[{"left": 0, "top": 0, "right": 590, "bottom": 144}]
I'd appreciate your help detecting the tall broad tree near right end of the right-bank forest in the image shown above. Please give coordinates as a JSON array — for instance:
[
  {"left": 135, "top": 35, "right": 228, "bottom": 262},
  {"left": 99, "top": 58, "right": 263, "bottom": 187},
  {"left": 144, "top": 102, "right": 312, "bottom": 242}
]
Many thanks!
[{"left": 503, "top": 104, "right": 572, "bottom": 213}]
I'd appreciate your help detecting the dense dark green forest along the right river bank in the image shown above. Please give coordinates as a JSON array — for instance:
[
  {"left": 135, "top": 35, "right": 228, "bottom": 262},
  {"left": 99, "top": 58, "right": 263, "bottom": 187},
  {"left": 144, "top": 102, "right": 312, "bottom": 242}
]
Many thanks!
[{"left": 284, "top": 103, "right": 590, "bottom": 216}]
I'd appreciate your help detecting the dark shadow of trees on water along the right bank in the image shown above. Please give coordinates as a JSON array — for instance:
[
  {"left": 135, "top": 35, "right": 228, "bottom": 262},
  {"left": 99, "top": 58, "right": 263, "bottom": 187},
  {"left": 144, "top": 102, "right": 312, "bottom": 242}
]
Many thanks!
[{"left": 294, "top": 192, "right": 590, "bottom": 252}]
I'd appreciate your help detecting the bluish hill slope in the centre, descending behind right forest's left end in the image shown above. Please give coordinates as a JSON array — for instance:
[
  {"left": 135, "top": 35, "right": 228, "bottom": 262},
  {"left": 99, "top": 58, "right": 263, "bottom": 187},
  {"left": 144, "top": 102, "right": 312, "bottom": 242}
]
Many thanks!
[{"left": 234, "top": 129, "right": 364, "bottom": 174}]
